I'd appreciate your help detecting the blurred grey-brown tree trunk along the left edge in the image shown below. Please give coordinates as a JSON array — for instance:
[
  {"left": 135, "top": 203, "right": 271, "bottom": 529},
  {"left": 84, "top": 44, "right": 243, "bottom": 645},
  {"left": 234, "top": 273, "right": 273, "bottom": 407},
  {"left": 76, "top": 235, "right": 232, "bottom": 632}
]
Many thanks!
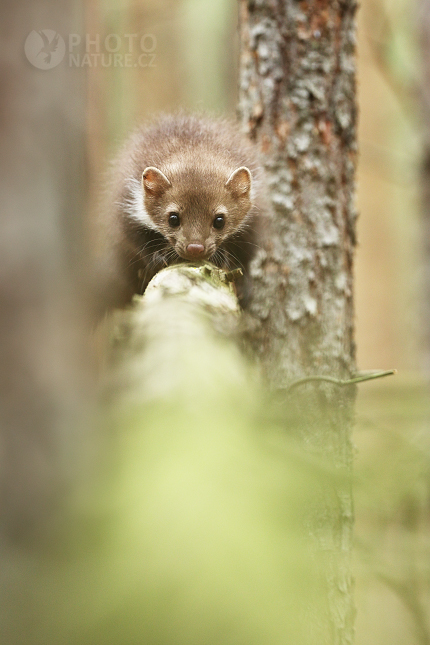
[{"left": 0, "top": 0, "right": 91, "bottom": 543}]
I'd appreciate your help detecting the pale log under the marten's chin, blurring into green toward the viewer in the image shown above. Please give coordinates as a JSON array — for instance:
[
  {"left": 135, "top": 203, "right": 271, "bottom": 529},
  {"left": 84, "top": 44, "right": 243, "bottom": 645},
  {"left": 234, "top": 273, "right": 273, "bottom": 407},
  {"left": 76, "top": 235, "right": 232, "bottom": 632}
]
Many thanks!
[{"left": 68, "top": 265, "right": 327, "bottom": 645}]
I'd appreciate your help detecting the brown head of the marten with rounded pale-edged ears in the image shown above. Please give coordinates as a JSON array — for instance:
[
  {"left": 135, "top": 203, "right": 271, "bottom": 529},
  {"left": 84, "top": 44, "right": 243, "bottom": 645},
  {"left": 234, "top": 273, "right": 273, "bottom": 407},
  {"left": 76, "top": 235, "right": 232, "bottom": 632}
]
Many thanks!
[{"left": 136, "top": 164, "right": 252, "bottom": 260}]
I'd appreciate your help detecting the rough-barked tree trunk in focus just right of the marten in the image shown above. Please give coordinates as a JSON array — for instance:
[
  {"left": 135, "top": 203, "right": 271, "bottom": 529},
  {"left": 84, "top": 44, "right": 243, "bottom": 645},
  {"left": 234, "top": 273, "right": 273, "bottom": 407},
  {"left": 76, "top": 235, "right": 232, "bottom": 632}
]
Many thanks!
[{"left": 239, "top": 0, "right": 357, "bottom": 644}]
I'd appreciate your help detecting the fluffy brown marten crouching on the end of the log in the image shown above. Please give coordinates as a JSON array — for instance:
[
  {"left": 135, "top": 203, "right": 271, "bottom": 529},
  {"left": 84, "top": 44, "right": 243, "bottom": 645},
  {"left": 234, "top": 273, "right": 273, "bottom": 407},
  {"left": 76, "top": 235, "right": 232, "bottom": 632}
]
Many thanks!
[{"left": 96, "top": 115, "right": 264, "bottom": 308}]
